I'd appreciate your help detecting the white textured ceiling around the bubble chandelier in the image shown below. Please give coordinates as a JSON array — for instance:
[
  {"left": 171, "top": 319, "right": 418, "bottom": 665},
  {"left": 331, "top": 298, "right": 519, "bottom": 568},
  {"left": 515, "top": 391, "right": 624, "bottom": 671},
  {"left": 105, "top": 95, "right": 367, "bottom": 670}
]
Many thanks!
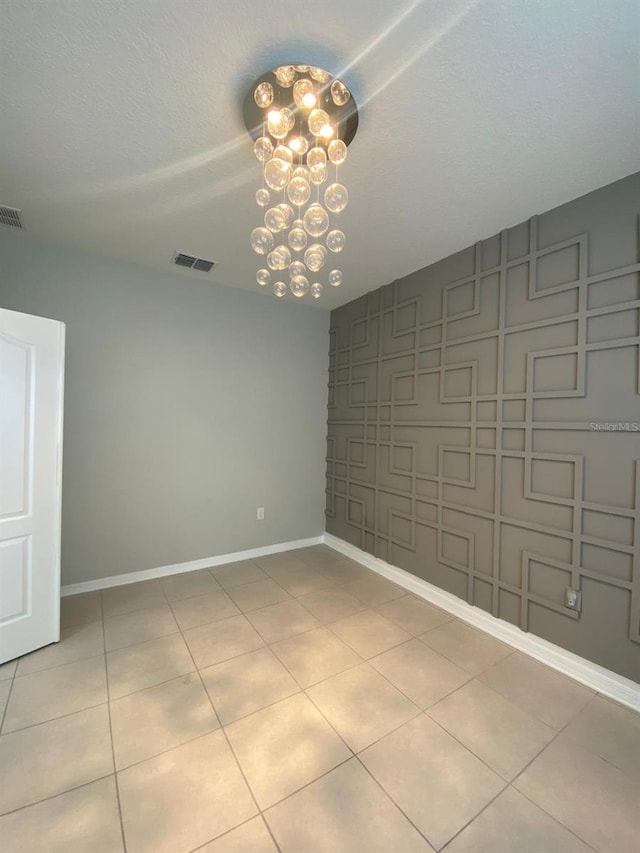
[{"left": 0, "top": 0, "right": 640, "bottom": 309}]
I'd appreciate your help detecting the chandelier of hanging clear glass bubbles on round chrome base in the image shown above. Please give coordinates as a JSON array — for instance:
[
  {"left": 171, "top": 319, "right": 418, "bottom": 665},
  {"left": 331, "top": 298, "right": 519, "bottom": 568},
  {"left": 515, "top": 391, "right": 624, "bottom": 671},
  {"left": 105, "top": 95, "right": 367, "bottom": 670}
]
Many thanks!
[{"left": 244, "top": 65, "right": 358, "bottom": 299}]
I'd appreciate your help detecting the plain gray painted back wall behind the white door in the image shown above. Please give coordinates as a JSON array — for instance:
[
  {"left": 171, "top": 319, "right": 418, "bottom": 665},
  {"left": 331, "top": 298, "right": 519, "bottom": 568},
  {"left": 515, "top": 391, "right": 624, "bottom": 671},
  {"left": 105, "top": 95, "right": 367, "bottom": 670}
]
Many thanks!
[{"left": 0, "top": 232, "right": 329, "bottom": 584}]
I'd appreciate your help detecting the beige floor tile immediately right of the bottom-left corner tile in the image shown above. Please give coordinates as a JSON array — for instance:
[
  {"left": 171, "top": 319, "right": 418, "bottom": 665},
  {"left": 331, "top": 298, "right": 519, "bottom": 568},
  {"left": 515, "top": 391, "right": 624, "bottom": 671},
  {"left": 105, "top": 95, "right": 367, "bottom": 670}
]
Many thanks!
[{"left": 118, "top": 732, "right": 257, "bottom": 853}]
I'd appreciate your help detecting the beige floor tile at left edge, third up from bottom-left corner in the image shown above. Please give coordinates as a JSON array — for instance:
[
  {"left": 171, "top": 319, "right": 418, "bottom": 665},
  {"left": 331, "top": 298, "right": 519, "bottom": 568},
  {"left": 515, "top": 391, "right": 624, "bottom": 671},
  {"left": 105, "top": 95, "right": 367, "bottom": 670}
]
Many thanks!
[{"left": 2, "top": 656, "right": 107, "bottom": 734}]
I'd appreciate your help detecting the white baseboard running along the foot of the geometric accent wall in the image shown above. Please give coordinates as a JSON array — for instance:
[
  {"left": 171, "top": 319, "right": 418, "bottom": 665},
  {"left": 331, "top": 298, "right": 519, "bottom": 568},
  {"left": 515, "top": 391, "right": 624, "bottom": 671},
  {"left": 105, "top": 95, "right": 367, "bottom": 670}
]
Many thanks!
[{"left": 323, "top": 533, "right": 640, "bottom": 711}]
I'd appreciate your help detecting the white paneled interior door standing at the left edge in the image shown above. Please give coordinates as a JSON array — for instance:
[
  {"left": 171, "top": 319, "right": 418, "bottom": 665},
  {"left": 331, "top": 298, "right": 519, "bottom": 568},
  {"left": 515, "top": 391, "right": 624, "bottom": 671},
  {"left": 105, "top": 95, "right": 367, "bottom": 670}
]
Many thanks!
[{"left": 0, "top": 308, "right": 64, "bottom": 663}]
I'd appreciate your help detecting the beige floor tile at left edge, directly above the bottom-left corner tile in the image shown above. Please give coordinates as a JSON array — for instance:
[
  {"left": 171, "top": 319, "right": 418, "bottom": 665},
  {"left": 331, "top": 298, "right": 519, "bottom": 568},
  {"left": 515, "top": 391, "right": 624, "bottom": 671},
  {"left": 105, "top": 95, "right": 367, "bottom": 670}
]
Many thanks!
[{"left": 0, "top": 705, "right": 113, "bottom": 814}]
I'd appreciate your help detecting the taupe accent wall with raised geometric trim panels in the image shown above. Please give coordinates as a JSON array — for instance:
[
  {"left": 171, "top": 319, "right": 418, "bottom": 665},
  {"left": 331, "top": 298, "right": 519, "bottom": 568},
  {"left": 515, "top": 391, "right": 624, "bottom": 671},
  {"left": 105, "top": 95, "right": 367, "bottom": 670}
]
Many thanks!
[{"left": 327, "top": 173, "right": 640, "bottom": 681}]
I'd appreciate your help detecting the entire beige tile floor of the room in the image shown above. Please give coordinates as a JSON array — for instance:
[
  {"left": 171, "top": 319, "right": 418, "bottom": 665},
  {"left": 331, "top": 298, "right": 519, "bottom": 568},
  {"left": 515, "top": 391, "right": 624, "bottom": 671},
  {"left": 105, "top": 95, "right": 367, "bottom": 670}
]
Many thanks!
[{"left": 0, "top": 546, "right": 640, "bottom": 853}]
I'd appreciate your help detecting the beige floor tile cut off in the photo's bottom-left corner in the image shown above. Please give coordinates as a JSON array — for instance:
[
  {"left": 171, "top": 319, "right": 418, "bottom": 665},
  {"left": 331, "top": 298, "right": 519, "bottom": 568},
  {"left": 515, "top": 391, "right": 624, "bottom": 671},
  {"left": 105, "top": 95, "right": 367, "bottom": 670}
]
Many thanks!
[{"left": 0, "top": 776, "right": 124, "bottom": 853}]
